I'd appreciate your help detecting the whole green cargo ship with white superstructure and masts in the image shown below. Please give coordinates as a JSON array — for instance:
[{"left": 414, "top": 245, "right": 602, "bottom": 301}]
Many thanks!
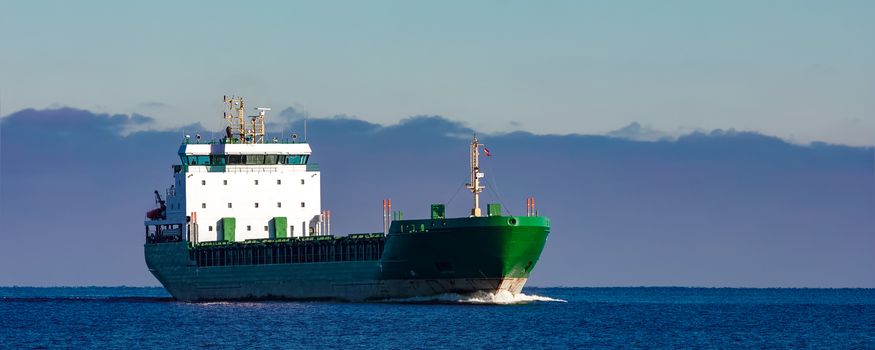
[{"left": 144, "top": 96, "right": 550, "bottom": 301}]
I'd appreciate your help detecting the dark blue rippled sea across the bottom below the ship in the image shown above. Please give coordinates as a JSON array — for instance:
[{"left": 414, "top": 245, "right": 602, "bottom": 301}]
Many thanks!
[{"left": 0, "top": 287, "right": 875, "bottom": 349}]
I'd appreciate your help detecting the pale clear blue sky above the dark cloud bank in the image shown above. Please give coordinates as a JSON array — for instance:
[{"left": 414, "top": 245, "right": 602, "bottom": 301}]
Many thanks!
[{"left": 0, "top": 1, "right": 875, "bottom": 145}]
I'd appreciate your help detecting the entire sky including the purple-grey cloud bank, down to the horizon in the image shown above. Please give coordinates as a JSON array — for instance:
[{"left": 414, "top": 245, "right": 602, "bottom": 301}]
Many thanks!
[{"left": 0, "top": 1, "right": 875, "bottom": 288}]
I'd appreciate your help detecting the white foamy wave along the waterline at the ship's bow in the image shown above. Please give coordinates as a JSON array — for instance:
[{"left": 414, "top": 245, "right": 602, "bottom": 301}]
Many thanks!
[{"left": 383, "top": 290, "right": 567, "bottom": 305}]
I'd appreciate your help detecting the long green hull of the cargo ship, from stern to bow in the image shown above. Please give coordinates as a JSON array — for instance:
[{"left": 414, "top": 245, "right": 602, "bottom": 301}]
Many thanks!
[{"left": 145, "top": 216, "right": 550, "bottom": 301}]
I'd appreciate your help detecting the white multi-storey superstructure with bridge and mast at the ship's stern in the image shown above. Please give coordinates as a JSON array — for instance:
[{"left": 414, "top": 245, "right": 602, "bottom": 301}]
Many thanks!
[{"left": 146, "top": 97, "right": 327, "bottom": 243}]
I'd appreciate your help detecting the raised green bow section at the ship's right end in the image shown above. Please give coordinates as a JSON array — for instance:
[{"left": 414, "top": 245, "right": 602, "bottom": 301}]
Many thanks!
[{"left": 381, "top": 216, "right": 550, "bottom": 296}]
